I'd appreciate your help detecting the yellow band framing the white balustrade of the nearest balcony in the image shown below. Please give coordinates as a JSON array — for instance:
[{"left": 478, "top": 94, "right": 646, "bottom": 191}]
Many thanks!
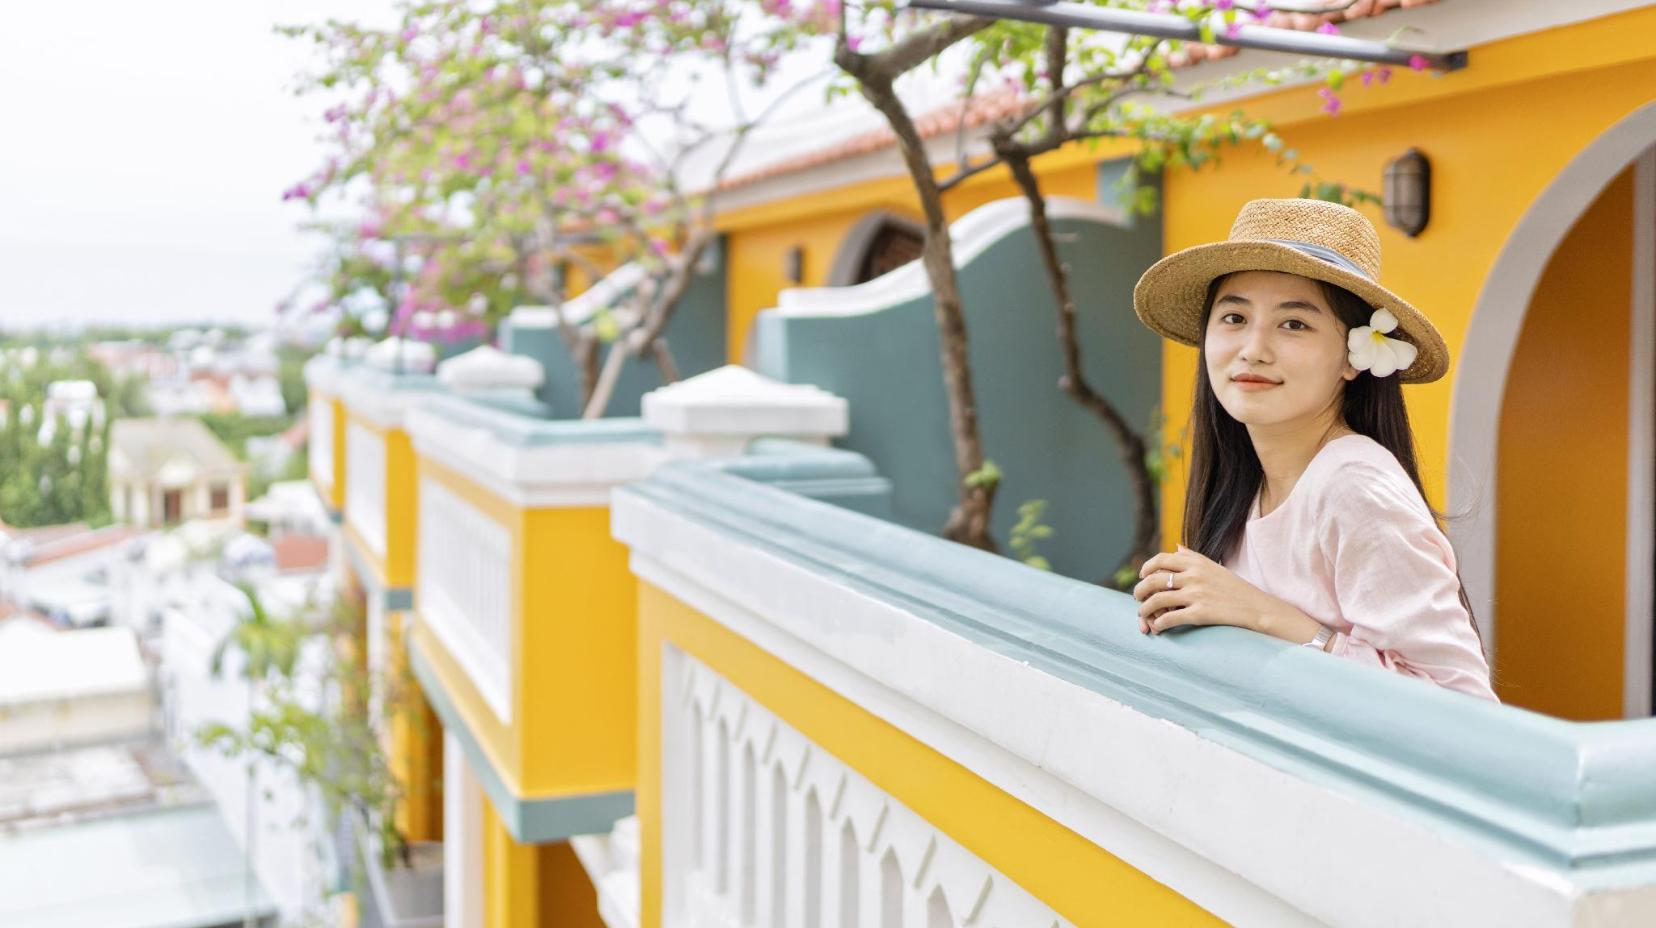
[{"left": 638, "top": 583, "right": 1219, "bottom": 928}]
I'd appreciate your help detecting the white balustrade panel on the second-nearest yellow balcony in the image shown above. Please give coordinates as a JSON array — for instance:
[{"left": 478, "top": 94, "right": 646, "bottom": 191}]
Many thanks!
[{"left": 416, "top": 477, "right": 513, "bottom": 723}]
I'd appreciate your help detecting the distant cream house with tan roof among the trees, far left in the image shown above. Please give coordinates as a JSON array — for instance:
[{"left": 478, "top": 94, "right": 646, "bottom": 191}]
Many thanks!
[{"left": 109, "top": 418, "right": 247, "bottom": 529}]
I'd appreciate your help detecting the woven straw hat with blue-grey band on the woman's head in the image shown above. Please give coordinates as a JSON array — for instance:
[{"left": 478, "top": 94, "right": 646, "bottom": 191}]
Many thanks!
[{"left": 1133, "top": 199, "right": 1449, "bottom": 383}]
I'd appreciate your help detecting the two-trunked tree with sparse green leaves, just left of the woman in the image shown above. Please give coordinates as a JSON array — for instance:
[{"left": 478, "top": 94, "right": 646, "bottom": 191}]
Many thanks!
[{"left": 835, "top": 0, "right": 1397, "bottom": 570}]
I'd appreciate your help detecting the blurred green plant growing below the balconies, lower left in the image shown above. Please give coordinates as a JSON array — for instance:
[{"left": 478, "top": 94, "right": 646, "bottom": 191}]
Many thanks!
[{"left": 195, "top": 587, "right": 409, "bottom": 868}]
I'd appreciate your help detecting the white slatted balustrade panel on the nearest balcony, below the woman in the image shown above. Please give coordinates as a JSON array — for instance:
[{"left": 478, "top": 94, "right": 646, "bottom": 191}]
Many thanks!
[{"left": 661, "top": 648, "right": 1068, "bottom": 928}]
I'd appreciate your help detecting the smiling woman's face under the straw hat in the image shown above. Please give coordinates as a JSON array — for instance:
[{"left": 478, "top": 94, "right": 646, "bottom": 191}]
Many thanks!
[{"left": 1204, "top": 270, "right": 1358, "bottom": 426}]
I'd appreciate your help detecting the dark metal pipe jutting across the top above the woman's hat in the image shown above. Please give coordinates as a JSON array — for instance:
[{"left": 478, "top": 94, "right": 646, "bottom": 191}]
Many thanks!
[{"left": 904, "top": 0, "right": 1467, "bottom": 71}]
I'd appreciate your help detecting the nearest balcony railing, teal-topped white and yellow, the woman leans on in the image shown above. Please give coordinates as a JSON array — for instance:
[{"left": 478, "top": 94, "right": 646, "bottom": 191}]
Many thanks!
[{"left": 614, "top": 461, "right": 1656, "bottom": 926}]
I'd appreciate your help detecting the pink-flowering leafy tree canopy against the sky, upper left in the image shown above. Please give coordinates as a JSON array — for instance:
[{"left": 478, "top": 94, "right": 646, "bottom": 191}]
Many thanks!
[{"left": 283, "top": 0, "right": 836, "bottom": 414}]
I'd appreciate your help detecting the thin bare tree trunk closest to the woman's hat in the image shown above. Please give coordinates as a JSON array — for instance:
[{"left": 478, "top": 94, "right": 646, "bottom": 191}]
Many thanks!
[{"left": 997, "top": 148, "right": 1161, "bottom": 587}]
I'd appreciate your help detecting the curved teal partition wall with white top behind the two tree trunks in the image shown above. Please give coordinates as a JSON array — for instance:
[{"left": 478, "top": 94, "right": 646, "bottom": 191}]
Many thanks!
[{"left": 755, "top": 176, "right": 1161, "bottom": 580}]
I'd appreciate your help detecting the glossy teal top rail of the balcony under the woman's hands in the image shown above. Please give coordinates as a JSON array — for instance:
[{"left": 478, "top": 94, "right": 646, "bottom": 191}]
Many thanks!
[{"left": 618, "top": 447, "right": 1656, "bottom": 883}]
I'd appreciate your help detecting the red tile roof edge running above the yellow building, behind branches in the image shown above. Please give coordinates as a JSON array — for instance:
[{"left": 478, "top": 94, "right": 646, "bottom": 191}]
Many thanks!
[{"left": 719, "top": 0, "right": 1439, "bottom": 191}]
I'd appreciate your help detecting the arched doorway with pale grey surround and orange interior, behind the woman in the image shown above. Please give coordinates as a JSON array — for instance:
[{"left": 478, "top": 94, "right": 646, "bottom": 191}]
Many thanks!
[{"left": 1449, "top": 104, "right": 1656, "bottom": 718}]
